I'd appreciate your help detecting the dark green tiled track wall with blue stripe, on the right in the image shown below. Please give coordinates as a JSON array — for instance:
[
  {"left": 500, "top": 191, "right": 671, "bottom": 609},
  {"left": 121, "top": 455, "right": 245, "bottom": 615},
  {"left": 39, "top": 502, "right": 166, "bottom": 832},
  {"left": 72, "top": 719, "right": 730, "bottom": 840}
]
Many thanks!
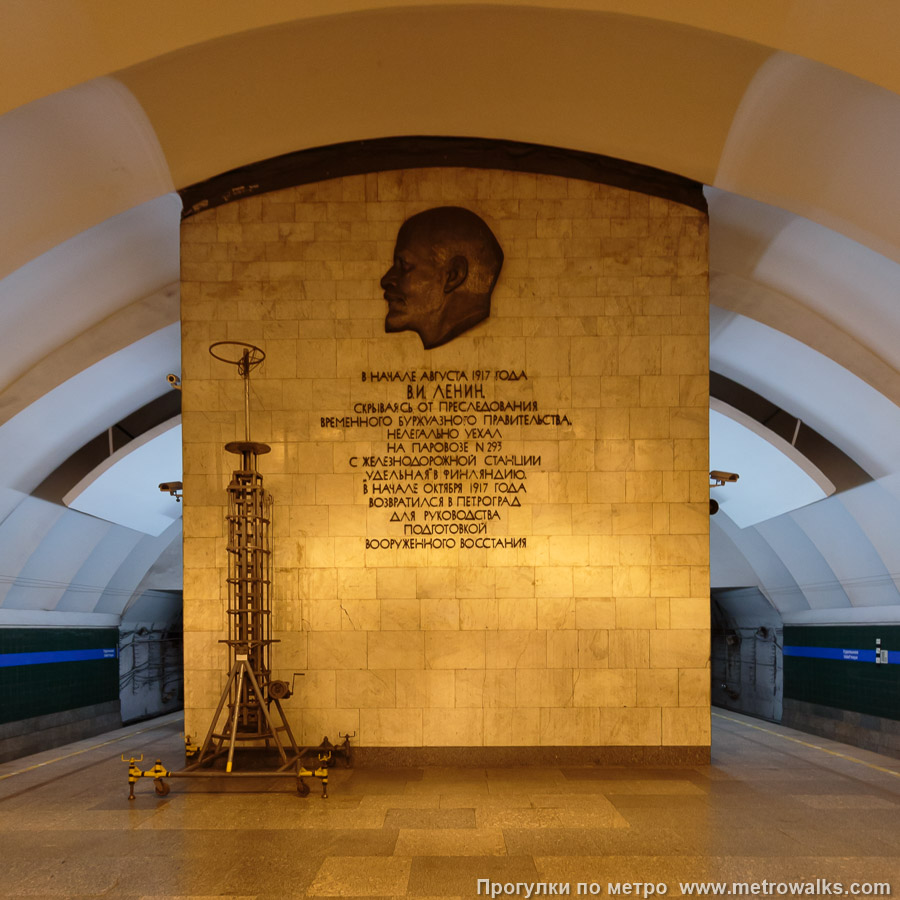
[{"left": 784, "top": 625, "right": 900, "bottom": 719}]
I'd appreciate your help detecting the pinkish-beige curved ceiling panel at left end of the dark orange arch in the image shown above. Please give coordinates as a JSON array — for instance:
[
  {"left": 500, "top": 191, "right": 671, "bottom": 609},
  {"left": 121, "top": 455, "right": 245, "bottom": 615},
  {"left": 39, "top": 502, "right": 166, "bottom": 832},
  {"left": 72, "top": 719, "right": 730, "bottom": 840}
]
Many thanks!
[{"left": 0, "top": 77, "right": 173, "bottom": 278}]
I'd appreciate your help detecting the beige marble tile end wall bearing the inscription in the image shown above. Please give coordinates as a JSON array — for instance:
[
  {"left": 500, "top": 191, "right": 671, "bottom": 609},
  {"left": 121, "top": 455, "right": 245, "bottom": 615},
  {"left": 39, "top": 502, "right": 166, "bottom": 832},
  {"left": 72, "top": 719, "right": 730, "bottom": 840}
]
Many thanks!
[{"left": 182, "top": 169, "right": 709, "bottom": 747}]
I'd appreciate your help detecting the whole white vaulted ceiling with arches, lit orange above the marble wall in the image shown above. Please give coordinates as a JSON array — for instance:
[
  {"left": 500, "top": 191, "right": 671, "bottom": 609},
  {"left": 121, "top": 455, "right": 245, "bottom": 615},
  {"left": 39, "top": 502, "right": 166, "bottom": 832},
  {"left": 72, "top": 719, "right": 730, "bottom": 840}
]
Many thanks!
[{"left": 0, "top": 0, "right": 900, "bottom": 624}]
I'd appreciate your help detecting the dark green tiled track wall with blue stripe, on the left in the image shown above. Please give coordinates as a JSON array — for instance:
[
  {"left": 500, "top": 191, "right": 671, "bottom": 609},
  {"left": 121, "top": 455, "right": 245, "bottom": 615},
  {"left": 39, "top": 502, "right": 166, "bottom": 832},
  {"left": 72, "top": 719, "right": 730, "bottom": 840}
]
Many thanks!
[{"left": 0, "top": 628, "right": 119, "bottom": 723}]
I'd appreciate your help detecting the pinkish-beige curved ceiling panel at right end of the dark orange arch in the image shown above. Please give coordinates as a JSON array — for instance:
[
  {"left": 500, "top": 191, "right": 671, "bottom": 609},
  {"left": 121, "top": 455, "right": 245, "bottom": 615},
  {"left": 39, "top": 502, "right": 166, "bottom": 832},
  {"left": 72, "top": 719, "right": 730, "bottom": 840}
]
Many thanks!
[{"left": 711, "top": 53, "right": 900, "bottom": 260}]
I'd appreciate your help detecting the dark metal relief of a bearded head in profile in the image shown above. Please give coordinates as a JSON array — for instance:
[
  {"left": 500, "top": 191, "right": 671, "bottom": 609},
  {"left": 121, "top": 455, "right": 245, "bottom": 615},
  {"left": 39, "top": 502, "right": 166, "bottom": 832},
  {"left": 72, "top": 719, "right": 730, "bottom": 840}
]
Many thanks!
[{"left": 381, "top": 206, "right": 503, "bottom": 350}]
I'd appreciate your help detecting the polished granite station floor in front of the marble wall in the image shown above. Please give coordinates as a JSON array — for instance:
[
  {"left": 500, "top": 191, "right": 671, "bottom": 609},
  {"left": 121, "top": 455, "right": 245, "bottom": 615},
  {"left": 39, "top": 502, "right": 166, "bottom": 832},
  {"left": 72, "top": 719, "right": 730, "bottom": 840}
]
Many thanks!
[{"left": 0, "top": 711, "right": 900, "bottom": 898}]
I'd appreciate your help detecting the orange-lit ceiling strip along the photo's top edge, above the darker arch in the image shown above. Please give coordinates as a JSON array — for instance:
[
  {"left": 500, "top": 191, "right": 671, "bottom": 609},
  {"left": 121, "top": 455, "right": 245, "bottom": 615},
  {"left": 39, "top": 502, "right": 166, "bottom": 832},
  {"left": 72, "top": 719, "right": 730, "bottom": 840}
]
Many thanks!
[{"left": 0, "top": 0, "right": 900, "bottom": 111}]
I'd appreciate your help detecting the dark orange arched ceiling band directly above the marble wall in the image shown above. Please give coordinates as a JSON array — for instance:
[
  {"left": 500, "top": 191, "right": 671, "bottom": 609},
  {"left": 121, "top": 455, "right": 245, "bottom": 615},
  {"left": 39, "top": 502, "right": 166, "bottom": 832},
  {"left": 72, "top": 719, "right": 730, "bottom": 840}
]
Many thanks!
[{"left": 116, "top": 5, "right": 770, "bottom": 187}]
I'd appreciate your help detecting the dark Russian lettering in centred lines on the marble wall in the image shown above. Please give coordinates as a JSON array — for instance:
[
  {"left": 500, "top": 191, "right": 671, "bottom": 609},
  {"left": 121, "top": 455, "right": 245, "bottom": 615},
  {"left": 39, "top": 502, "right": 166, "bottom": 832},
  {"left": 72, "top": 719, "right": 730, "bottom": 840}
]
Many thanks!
[{"left": 320, "top": 369, "right": 572, "bottom": 550}]
